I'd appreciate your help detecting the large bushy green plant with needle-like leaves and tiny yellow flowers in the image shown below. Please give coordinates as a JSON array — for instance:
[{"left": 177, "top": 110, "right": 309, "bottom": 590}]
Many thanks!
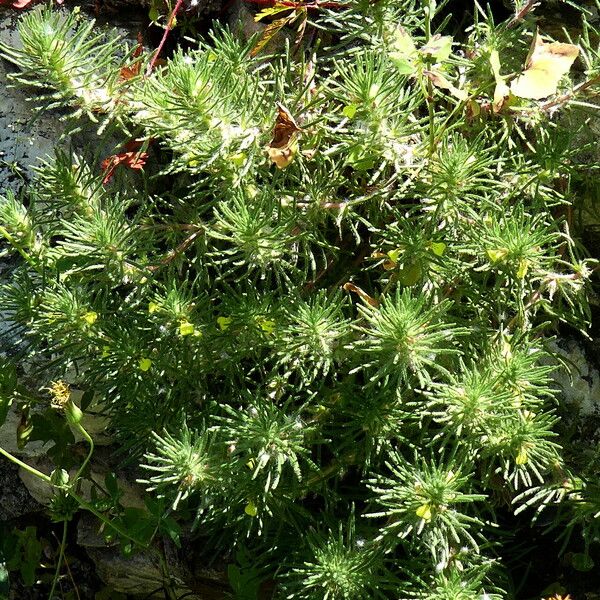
[{"left": 0, "top": 0, "right": 600, "bottom": 600}]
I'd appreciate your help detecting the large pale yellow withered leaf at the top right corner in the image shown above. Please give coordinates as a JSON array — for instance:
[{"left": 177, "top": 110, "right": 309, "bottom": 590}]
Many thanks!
[{"left": 510, "top": 32, "right": 579, "bottom": 100}]
